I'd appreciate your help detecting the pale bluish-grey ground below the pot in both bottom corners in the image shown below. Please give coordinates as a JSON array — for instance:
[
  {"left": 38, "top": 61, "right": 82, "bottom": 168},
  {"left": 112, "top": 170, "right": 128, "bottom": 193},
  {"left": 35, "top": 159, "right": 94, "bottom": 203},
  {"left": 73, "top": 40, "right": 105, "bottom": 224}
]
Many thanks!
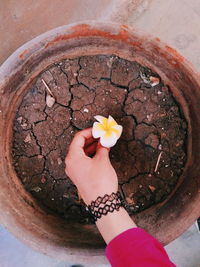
[{"left": 0, "top": 225, "right": 200, "bottom": 267}]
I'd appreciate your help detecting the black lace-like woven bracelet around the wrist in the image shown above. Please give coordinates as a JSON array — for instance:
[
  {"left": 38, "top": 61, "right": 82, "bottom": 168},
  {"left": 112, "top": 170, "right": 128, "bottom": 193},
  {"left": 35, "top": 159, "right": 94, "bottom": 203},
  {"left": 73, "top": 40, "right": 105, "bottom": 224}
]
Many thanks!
[{"left": 88, "top": 191, "right": 123, "bottom": 222}]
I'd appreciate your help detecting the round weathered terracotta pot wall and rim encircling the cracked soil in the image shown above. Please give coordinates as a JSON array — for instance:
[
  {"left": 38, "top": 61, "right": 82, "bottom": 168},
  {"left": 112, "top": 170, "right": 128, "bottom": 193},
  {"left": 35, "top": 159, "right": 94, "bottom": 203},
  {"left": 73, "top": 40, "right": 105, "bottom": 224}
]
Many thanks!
[{"left": 0, "top": 21, "right": 200, "bottom": 263}]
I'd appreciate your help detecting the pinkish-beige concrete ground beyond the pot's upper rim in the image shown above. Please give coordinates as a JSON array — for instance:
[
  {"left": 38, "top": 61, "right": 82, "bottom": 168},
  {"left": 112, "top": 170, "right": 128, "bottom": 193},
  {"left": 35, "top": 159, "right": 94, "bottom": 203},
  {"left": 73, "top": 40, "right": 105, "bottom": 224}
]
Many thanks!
[{"left": 0, "top": 0, "right": 200, "bottom": 71}]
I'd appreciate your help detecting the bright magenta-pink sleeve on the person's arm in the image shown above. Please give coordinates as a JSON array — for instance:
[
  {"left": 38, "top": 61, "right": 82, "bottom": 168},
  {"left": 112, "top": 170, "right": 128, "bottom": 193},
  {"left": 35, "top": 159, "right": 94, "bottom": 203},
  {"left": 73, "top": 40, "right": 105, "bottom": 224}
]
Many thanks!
[{"left": 106, "top": 228, "right": 175, "bottom": 267}]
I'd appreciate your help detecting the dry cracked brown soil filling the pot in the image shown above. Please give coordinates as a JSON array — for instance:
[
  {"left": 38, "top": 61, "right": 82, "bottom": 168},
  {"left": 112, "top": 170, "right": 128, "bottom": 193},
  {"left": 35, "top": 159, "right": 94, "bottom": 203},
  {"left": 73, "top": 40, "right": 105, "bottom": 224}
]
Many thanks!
[{"left": 12, "top": 55, "right": 187, "bottom": 223}]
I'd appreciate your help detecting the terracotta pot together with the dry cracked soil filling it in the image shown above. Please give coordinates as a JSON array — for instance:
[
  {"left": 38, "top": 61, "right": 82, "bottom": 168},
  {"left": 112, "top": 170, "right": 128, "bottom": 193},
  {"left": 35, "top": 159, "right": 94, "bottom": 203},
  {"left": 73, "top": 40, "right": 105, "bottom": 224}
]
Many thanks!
[{"left": 0, "top": 24, "right": 200, "bottom": 260}]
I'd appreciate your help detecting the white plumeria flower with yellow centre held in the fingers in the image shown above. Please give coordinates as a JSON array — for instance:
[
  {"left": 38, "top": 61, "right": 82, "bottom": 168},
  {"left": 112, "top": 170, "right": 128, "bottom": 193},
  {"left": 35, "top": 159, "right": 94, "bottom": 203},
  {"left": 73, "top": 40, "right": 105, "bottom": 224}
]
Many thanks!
[{"left": 92, "top": 115, "right": 123, "bottom": 148}]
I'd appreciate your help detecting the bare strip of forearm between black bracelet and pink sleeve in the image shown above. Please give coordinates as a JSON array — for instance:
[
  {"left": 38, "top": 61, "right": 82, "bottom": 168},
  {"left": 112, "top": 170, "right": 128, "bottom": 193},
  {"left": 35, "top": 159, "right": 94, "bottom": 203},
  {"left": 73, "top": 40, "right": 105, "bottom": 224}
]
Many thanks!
[{"left": 96, "top": 207, "right": 137, "bottom": 244}]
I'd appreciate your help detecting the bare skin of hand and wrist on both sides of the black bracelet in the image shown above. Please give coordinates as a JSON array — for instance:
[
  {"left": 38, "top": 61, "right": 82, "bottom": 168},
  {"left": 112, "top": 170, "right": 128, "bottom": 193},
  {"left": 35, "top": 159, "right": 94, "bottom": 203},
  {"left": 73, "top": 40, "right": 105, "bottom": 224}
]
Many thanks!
[{"left": 65, "top": 128, "right": 136, "bottom": 244}]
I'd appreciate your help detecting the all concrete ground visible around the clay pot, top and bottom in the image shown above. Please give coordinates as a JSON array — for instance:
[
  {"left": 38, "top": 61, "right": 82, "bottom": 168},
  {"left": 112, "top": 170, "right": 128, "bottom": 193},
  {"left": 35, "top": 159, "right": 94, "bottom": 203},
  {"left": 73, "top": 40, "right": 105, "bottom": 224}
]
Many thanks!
[{"left": 0, "top": 0, "right": 200, "bottom": 267}]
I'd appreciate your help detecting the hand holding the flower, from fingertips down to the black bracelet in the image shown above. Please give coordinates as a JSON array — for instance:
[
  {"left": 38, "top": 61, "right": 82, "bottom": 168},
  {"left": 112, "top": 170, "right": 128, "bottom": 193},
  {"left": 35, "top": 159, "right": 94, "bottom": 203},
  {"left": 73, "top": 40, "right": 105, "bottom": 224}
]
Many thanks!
[{"left": 65, "top": 128, "right": 118, "bottom": 205}]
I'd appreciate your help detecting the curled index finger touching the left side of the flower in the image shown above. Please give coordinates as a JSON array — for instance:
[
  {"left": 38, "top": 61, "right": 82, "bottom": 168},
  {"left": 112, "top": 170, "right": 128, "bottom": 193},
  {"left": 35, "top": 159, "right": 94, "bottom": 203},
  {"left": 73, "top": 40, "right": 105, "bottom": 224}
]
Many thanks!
[{"left": 69, "top": 128, "right": 92, "bottom": 155}]
